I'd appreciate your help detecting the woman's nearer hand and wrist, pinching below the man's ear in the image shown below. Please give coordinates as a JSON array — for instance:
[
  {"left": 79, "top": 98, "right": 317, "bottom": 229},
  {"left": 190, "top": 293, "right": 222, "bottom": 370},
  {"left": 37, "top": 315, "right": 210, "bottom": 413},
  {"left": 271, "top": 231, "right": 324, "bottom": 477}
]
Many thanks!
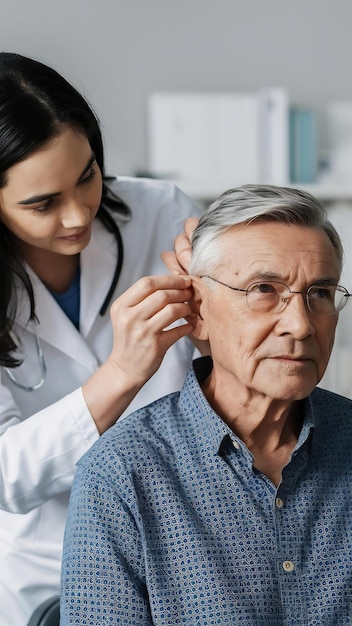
[{"left": 82, "top": 274, "right": 193, "bottom": 433}]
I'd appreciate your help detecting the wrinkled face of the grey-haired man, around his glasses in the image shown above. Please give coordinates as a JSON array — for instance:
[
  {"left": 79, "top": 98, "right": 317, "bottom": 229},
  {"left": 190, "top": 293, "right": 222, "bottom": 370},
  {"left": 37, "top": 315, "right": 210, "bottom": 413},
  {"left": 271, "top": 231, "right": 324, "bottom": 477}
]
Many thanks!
[{"left": 195, "top": 223, "right": 341, "bottom": 401}]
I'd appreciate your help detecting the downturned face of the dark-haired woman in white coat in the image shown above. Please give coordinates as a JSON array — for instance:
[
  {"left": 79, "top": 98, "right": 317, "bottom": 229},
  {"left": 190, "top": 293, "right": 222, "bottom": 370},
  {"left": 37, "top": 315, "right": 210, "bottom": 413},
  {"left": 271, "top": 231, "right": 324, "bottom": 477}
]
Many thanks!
[{"left": 0, "top": 127, "right": 102, "bottom": 257}]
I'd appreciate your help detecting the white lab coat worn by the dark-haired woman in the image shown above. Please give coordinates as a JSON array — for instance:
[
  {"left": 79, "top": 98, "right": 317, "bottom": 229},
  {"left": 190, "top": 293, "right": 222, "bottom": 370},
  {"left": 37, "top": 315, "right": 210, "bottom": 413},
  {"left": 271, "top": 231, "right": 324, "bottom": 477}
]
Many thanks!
[{"left": 0, "top": 177, "right": 198, "bottom": 626}]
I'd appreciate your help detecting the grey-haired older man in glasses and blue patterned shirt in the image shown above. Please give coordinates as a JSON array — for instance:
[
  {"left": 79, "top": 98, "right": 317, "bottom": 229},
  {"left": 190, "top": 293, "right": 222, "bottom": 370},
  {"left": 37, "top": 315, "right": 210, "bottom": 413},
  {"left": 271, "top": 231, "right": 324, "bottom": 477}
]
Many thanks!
[{"left": 61, "top": 186, "right": 352, "bottom": 626}]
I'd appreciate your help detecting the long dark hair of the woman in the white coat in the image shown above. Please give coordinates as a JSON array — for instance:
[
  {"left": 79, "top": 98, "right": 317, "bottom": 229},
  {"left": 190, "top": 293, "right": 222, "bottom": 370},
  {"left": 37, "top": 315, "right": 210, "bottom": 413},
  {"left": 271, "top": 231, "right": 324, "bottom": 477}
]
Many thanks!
[{"left": 0, "top": 52, "right": 129, "bottom": 367}]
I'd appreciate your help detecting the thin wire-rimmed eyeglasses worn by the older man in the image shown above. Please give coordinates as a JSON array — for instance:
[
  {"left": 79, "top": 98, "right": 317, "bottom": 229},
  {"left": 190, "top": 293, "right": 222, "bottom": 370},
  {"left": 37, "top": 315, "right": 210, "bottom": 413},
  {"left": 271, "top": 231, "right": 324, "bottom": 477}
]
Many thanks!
[{"left": 200, "top": 276, "right": 352, "bottom": 315}]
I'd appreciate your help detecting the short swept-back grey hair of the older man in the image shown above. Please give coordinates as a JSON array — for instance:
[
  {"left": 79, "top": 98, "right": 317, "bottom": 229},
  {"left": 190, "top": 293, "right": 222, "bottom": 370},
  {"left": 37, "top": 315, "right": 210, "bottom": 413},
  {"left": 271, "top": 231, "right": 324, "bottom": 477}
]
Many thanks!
[{"left": 190, "top": 185, "right": 344, "bottom": 275}]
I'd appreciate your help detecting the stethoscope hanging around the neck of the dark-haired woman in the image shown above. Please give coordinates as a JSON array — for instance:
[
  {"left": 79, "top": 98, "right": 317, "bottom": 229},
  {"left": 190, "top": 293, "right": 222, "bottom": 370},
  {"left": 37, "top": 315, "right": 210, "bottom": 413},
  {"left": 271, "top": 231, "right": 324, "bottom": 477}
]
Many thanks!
[{"left": 3, "top": 196, "right": 124, "bottom": 391}]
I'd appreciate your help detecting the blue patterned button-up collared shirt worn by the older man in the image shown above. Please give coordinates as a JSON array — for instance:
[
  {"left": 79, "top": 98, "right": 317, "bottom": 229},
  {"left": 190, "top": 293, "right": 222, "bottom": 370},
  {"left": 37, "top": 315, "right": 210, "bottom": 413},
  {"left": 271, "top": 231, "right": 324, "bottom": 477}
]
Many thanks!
[{"left": 61, "top": 359, "right": 352, "bottom": 626}]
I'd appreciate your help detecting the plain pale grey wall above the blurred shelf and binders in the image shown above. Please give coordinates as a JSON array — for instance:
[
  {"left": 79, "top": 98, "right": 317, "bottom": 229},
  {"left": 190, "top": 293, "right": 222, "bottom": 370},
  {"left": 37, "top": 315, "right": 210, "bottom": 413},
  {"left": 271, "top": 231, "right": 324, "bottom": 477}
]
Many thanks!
[{"left": 0, "top": 0, "right": 352, "bottom": 174}]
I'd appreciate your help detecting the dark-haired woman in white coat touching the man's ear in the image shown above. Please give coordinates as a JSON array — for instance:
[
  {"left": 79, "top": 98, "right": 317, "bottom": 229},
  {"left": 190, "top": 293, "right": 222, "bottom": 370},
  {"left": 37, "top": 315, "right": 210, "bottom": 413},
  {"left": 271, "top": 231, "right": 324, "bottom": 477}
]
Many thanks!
[{"left": 0, "top": 53, "right": 198, "bottom": 626}]
